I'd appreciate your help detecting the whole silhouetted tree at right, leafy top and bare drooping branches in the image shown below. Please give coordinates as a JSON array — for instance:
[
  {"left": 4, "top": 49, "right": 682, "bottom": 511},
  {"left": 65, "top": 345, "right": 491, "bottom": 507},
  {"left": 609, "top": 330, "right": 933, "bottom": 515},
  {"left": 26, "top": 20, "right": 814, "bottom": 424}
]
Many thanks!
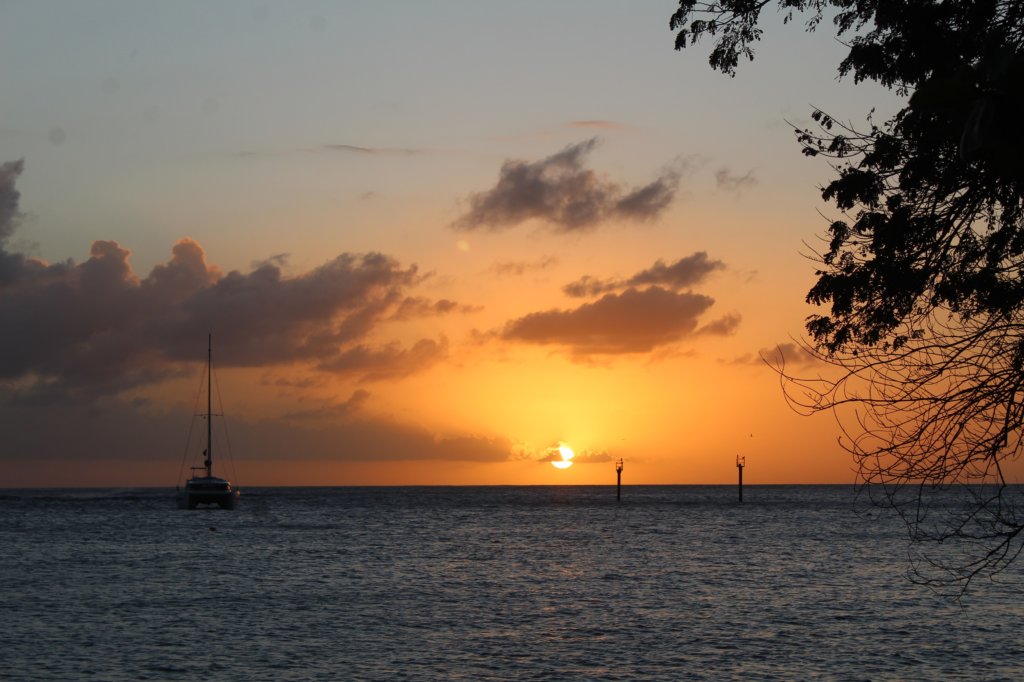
[{"left": 671, "top": 0, "right": 1024, "bottom": 589}]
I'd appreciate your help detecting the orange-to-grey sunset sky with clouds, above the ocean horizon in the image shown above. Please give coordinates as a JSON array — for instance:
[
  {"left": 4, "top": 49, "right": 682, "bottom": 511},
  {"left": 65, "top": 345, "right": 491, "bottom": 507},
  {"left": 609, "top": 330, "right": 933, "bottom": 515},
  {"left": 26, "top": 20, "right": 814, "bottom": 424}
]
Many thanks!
[{"left": 0, "top": 0, "right": 898, "bottom": 487}]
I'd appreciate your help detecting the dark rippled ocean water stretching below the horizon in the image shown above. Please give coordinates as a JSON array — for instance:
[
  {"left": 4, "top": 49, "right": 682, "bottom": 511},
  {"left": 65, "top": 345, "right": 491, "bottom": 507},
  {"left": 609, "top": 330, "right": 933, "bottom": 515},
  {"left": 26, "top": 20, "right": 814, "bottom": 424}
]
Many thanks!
[{"left": 0, "top": 486, "right": 1024, "bottom": 680}]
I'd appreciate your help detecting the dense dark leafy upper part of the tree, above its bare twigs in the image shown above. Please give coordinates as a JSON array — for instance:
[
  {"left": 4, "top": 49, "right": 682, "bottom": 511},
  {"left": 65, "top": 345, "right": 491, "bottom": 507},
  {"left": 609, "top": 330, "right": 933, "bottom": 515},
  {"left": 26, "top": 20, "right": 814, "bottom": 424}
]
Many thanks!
[{"left": 671, "top": 0, "right": 1024, "bottom": 351}]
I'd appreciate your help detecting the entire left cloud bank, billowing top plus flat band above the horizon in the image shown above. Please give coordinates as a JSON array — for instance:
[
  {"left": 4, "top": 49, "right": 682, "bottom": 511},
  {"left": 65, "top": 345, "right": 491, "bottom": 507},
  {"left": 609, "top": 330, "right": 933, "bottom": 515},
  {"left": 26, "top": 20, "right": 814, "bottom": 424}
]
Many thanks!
[{"left": 0, "top": 162, "right": 512, "bottom": 463}]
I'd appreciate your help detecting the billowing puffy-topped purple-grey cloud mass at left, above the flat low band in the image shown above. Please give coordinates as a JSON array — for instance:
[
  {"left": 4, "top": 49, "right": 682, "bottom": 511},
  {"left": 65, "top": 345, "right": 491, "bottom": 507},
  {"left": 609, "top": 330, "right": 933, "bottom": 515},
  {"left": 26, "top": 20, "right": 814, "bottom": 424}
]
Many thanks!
[{"left": 0, "top": 162, "right": 465, "bottom": 402}]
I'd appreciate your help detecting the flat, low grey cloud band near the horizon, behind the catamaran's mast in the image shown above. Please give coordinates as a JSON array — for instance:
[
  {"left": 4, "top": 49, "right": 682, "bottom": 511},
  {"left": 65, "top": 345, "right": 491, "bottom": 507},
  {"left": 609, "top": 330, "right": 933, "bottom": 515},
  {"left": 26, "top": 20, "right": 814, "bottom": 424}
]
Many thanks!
[{"left": 0, "top": 391, "right": 512, "bottom": 462}]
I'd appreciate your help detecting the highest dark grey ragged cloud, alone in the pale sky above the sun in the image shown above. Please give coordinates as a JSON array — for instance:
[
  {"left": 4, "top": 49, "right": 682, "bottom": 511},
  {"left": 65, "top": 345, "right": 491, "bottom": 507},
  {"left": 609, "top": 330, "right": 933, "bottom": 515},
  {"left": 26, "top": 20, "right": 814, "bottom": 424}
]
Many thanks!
[{"left": 453, "top": 137, "right": 680, "bottom": 232}]
